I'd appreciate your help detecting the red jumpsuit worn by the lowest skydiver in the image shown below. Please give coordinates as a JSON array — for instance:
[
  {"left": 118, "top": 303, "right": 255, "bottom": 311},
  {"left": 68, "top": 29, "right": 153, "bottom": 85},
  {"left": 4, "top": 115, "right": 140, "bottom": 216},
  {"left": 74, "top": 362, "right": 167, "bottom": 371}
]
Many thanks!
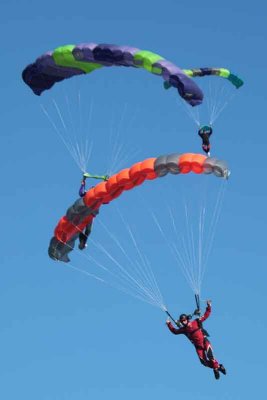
[{"left": 167, "top": 306, "right": 220, "bottom": 369}]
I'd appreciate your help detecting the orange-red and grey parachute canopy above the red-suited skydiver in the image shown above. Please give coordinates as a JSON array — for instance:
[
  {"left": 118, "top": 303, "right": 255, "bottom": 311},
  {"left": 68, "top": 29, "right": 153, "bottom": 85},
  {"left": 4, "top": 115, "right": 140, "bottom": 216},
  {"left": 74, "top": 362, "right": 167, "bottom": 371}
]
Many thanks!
[{"left": 48, "top": 153, "right": 230, "bottom": 262}]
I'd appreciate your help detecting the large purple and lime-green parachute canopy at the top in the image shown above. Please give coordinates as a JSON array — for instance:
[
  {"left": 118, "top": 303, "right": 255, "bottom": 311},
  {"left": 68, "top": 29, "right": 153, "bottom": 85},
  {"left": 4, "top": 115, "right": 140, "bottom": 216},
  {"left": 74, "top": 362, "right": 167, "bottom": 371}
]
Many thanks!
[{"left": 22, "top": 43, "right": 203, "bottom": 106}]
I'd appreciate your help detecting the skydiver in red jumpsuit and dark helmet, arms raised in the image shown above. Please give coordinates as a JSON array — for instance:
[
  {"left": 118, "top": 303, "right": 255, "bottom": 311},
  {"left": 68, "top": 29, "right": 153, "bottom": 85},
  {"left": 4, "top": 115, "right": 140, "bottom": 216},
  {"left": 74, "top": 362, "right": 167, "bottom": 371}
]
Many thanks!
[{"left": 166, "top": 300, "right": 226, "bottom": 379}]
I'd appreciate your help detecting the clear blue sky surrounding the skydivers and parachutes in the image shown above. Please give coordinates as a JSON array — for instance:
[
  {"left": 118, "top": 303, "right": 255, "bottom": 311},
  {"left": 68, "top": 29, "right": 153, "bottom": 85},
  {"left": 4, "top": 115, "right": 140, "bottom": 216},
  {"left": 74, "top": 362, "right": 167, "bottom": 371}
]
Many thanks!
[{"left": 0, "top": 0, "right": 267, "bottom": 400}]
